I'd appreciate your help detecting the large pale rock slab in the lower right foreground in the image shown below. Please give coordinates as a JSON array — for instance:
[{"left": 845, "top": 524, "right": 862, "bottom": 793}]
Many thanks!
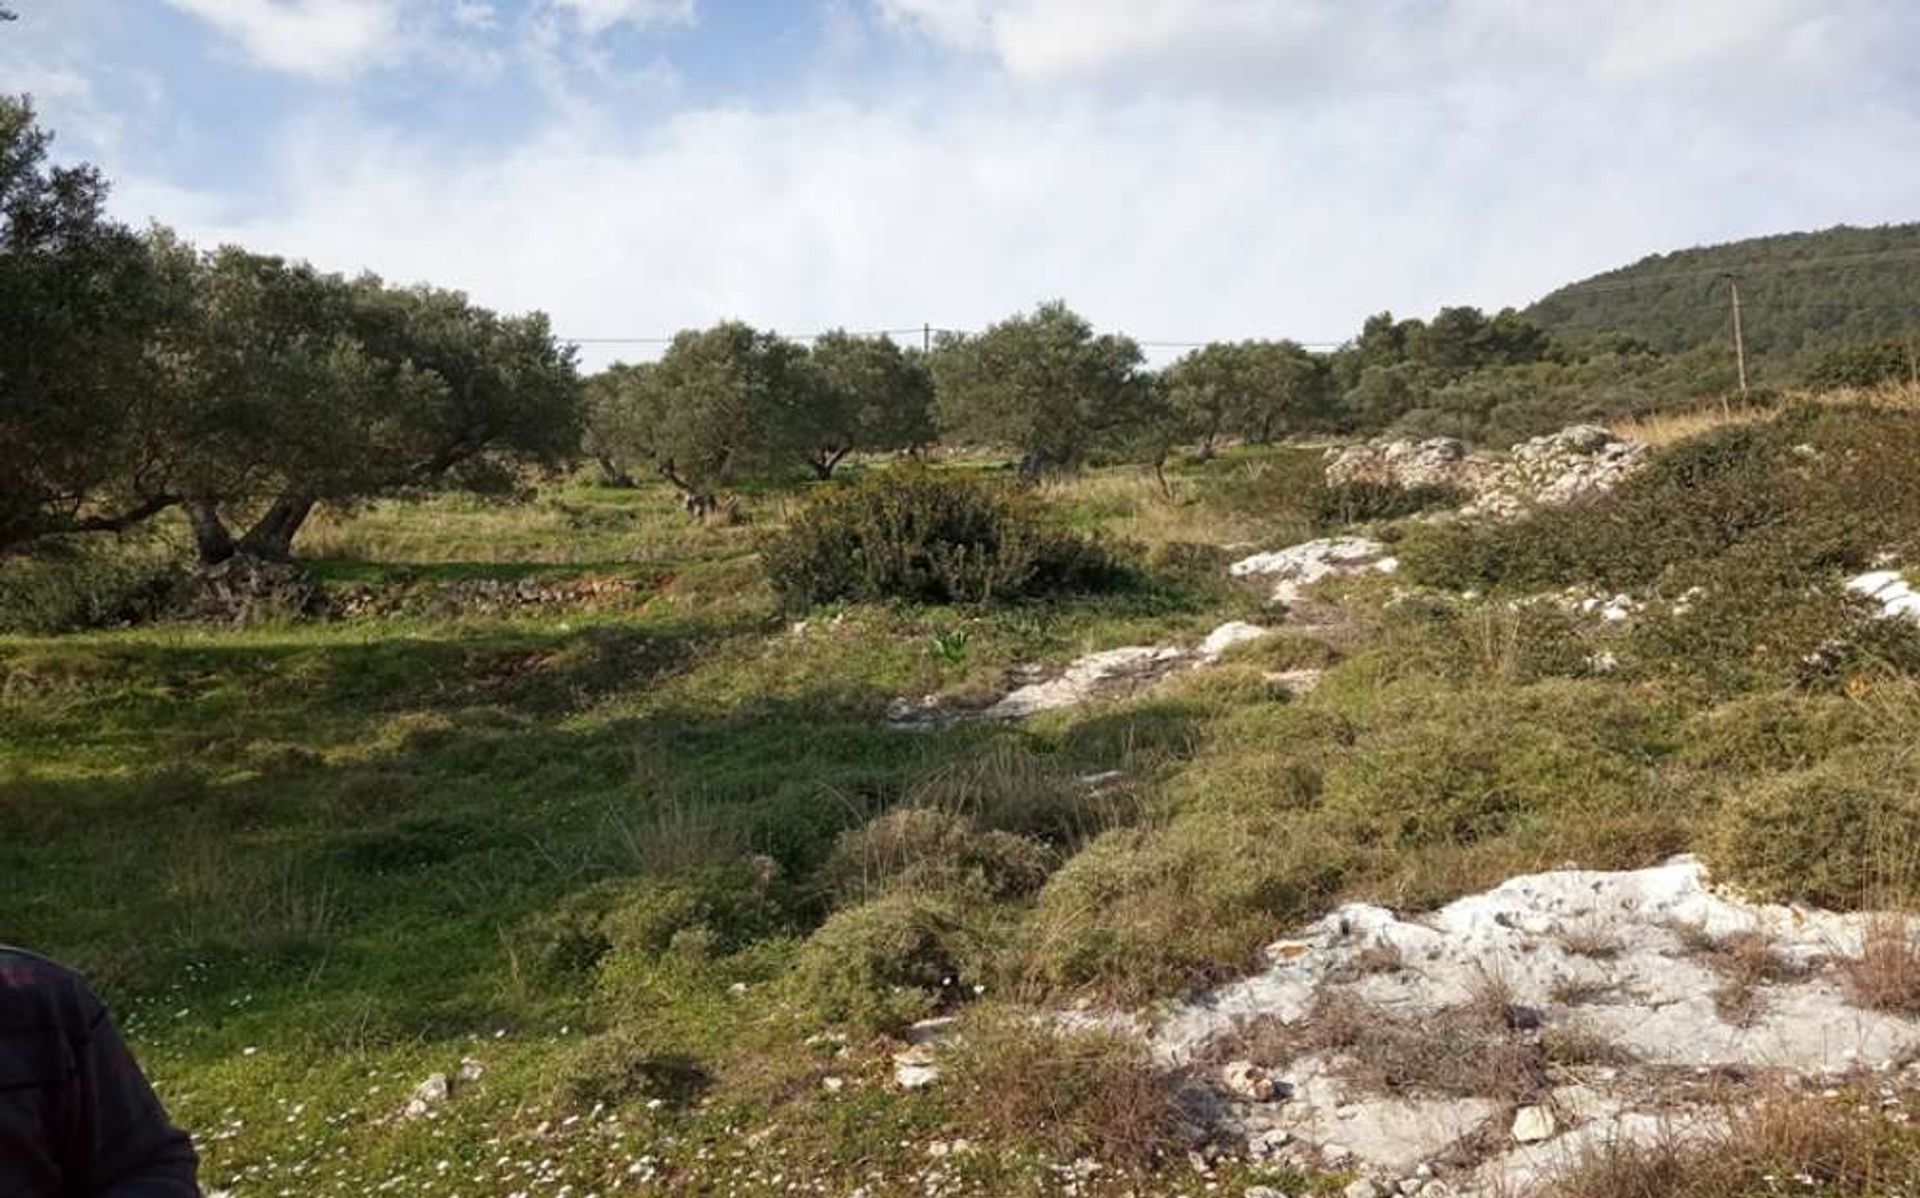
[{"left": 1144, "top": 858, "right": 1920, "bottom": 1196}]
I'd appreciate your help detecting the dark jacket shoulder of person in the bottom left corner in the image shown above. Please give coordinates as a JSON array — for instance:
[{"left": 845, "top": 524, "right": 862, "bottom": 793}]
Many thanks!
[{"left": 0, "top": 946, "right": 200, "bottom": 1198}]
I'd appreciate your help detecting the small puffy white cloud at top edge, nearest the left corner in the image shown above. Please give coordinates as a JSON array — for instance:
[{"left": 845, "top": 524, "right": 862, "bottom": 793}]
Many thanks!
[{"left": 167, "top": 0, "right": 399, "bottom": 79}]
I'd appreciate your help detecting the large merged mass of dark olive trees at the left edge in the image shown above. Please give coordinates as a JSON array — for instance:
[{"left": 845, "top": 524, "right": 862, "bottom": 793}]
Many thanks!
[{"left": 0, "top": 100, "right": 580, "bottom": 563}]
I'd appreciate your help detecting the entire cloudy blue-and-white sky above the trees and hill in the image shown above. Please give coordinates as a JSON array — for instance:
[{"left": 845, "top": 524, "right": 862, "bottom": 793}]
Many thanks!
[{"left": 0, "top": 0, "right": 1920, "bottom": 367}]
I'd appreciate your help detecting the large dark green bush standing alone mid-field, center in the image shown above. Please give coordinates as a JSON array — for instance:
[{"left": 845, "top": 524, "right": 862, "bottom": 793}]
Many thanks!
[{"left": 762, "top": 468, "right": 1127, "bottom": 609}]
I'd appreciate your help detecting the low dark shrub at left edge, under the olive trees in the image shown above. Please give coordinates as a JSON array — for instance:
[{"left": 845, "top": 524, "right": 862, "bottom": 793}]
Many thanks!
[{"left": 0, "top": 551, "right": 190, "bottom": 635}]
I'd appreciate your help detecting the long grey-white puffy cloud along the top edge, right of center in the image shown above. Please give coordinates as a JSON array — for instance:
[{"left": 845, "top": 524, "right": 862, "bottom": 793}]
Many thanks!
[{"left": 876, "top": 0, "right": 1920, "bottom": 98}]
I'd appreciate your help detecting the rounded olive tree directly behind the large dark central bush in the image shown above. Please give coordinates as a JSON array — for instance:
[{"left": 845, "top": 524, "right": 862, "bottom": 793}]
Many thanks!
[{"left": 929, "top": 301, "right": 1152, "bottom": 474}]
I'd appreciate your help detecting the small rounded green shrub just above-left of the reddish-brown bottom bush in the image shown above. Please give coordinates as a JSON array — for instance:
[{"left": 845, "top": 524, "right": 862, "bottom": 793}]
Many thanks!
[{"left": 789, "top": 891, "right": 989, "bottom": 1031}]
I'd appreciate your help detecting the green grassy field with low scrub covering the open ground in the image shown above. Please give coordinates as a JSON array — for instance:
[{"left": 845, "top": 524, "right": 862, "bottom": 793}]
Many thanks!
[{"left": 11, "top": 405, "right": 1920, "bottom": 1198}]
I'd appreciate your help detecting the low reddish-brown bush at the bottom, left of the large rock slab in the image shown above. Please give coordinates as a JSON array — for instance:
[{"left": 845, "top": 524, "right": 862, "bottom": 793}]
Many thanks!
[{"left": 950, "top": 1012, "right": 1183, "bottom": 1169}]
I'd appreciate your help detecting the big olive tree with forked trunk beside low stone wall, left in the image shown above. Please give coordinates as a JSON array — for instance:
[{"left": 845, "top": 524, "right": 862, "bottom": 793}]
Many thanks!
[{"left": 159, "top": 246, "right": 580, "bottom": 564}]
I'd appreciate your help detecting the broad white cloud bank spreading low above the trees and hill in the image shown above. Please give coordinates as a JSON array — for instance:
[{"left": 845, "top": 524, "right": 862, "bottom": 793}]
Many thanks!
[{"left": 97, "top": 0, "right": 1920, "bottom": 370}]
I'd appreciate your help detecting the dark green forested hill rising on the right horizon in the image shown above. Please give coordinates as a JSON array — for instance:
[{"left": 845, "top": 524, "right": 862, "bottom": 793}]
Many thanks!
[{"left": 1526, "top": 223, "right": 1920, "bottom": 372}]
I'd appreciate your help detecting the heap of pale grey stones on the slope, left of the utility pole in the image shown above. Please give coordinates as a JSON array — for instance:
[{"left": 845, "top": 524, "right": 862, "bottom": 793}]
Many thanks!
[{"left": 1325, "top": 424, "right": 1647, "bottom": 518}]
